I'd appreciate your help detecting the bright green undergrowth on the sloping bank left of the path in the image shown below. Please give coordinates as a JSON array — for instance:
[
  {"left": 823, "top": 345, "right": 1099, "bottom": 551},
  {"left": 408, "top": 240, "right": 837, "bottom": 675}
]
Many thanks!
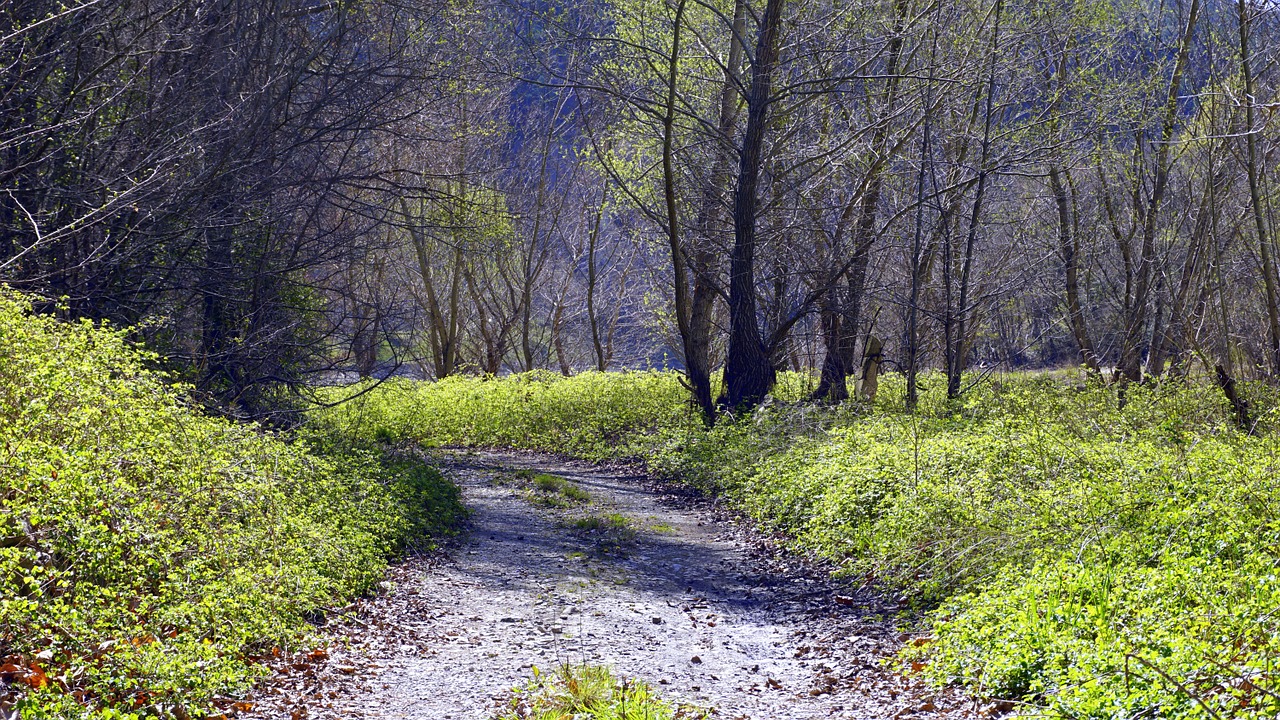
[{"left": 0, "top": 291, "right": 462, "bottom": 719}]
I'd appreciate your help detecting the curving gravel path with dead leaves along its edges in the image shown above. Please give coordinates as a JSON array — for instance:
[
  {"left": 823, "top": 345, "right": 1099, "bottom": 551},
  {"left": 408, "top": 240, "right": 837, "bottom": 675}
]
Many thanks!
[{"left": 240, "top": 451, "right": 977, "bottom": 720}]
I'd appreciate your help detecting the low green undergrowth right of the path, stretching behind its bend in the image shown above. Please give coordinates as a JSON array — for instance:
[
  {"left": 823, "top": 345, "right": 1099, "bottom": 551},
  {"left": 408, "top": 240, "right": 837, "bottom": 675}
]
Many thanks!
[{"left": 312, "top": 373, "right": 1280, "bottom": 717}]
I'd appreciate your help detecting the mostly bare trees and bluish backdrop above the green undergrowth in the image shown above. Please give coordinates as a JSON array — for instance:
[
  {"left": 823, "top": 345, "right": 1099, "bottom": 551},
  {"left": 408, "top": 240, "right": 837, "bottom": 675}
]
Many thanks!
[{"left": 0, "top": 0, "right": 1280, "bottom": 420}]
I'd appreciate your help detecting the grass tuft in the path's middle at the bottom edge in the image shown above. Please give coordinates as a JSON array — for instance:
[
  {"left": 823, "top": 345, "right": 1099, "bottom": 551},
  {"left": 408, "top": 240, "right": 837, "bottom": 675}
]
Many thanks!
[{"left": 495, "top": 665, "right": 707, "bottom": 720}]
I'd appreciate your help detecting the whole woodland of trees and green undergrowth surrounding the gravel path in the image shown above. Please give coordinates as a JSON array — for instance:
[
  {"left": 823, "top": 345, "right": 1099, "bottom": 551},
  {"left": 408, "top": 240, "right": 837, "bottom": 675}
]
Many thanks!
[{"left": 0, "top": 0, "right": 1280, "bottom": 720}]
